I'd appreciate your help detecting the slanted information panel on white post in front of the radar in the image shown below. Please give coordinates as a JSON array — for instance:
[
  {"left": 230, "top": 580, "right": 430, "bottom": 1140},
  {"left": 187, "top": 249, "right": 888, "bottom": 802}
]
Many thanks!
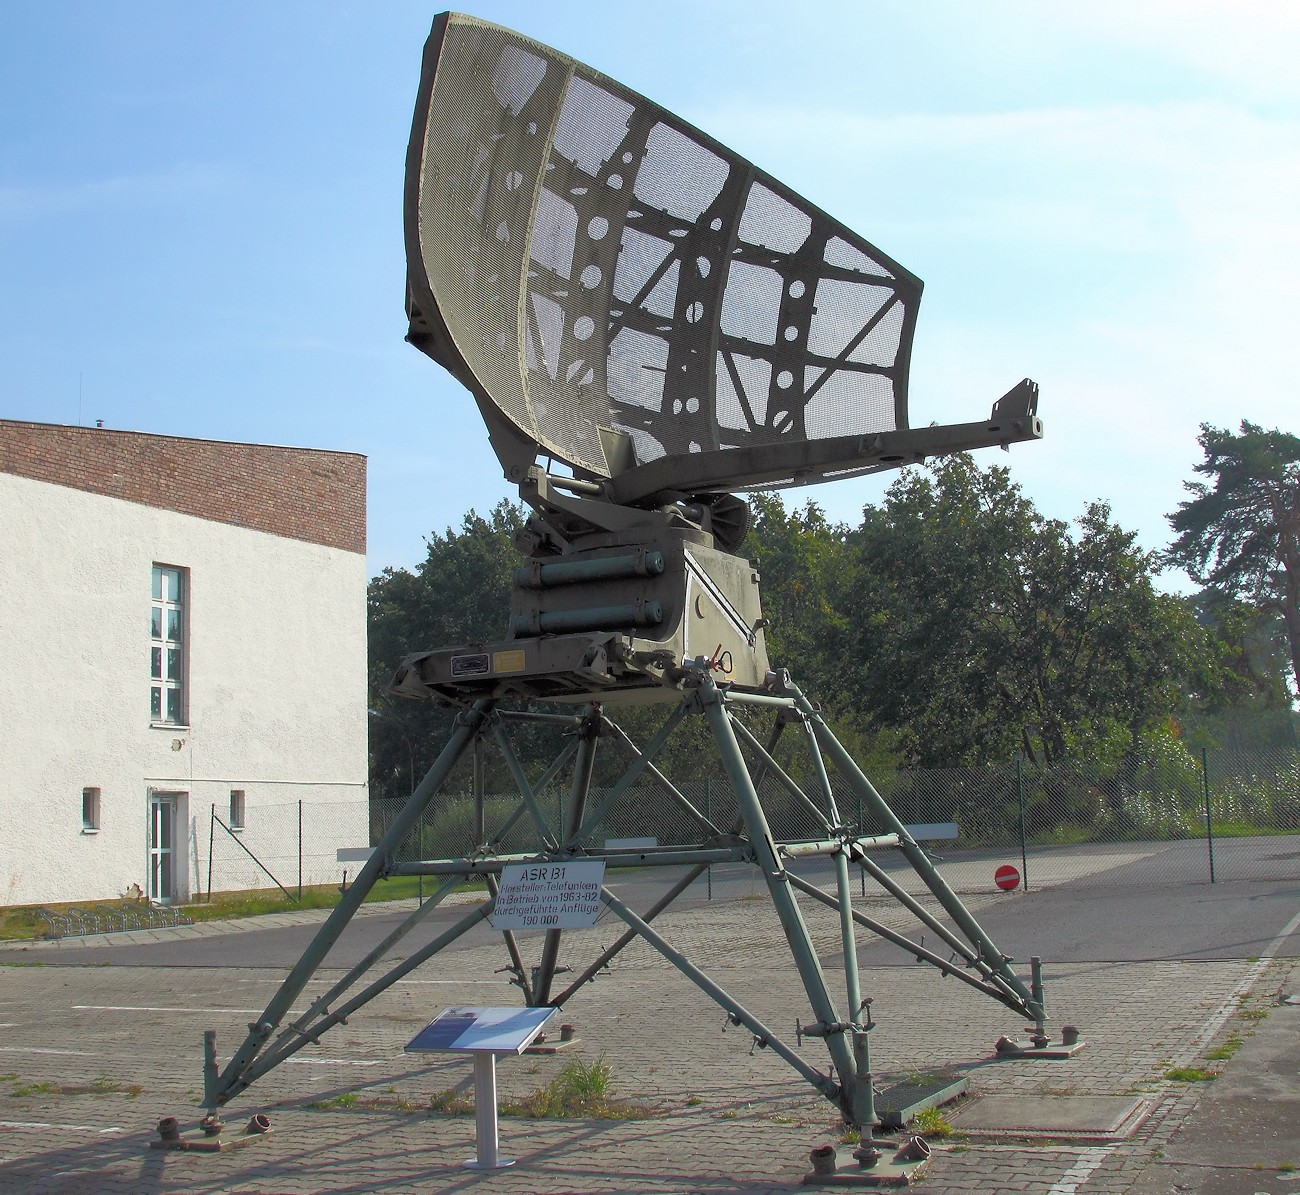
[{"left": 406, "top": 1008, "right": 559, "bottom": 1170}]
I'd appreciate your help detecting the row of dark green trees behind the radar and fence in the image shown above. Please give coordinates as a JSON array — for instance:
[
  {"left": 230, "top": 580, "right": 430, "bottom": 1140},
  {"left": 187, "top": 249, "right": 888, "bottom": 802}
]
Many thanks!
[{"left": 368, "top": 424, "right": 1300, "bottom": 796}]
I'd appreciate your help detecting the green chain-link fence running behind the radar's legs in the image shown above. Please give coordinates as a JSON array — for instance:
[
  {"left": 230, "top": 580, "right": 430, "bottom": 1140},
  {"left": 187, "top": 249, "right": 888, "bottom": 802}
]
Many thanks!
[{"left": 200, "top": 745, "right": 1300, "bottom": 892}]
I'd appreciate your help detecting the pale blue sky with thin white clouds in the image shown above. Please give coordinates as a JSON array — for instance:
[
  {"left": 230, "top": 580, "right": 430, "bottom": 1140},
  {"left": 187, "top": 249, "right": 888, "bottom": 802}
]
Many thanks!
[{"left": 0, "top": 0, "right": 1300, "bottom": 585}]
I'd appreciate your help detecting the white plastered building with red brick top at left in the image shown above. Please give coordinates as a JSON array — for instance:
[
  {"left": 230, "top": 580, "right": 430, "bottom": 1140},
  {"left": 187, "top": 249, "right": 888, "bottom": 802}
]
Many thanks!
[{"left": 0, "top": 420, "right": 368, "bottom": 906}]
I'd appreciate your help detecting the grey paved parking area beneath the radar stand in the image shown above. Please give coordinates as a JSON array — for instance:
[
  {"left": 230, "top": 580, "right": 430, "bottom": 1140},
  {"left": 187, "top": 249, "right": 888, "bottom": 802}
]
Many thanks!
[{"left": 0, "top": 900, "right": 1300, "bottom": 1195}]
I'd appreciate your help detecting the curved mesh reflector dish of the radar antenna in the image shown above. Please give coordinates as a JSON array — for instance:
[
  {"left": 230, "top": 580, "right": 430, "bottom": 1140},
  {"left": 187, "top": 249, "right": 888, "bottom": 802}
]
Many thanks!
[{"left": 407, "top": 14, "right": 920, "bottom": 480}]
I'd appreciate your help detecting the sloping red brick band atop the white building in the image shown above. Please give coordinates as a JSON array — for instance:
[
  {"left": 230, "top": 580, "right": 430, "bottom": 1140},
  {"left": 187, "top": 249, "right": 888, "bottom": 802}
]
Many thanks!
[{"left": 0, "top": 419, "right": 365, "bottom": 553}]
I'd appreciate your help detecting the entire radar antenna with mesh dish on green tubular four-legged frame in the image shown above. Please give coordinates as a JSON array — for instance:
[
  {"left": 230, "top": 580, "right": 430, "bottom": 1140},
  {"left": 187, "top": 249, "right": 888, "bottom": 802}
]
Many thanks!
[{"left": 183, "top": 10, "right": 1071, "bottom": 1173}]
